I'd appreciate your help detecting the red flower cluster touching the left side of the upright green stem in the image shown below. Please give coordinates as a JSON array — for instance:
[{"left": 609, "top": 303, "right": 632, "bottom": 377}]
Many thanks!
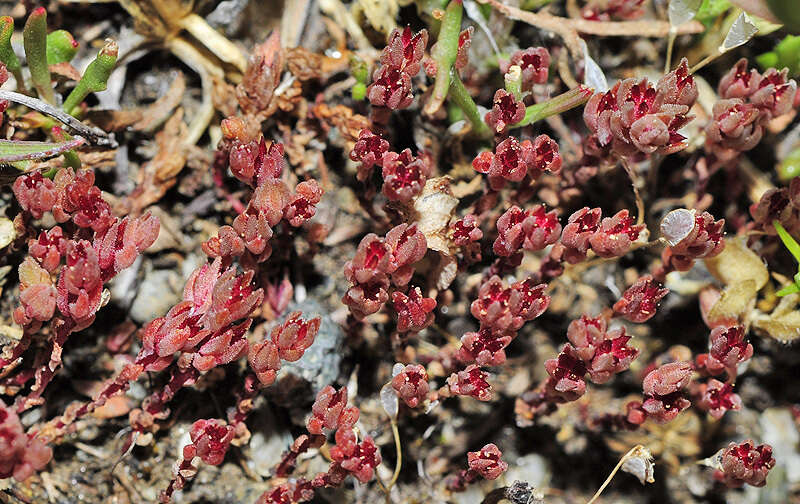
[{"left": 367, "top": 26, "right": 428, "bottom": 110}]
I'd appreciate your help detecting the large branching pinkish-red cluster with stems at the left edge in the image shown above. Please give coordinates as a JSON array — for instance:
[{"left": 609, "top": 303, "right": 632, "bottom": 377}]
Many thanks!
[{"left": 6, "top": 168, "right": 159, "bottom": 410}]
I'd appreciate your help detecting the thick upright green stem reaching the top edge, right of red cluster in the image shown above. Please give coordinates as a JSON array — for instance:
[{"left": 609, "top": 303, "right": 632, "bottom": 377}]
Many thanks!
[{"left": 425, "top": 0, "right": 464, "bottom": 115}]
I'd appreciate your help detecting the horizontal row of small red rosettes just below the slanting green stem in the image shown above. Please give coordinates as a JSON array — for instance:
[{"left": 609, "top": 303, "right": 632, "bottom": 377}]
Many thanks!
[{"left": 472, "top": 135, "right": 562, "bottom": 191}]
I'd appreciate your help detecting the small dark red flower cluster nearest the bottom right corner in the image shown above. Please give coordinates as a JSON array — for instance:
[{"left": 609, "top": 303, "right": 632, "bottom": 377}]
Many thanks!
[{"left": 714, "top": 439, "right": 775, "bottom": 488}]
